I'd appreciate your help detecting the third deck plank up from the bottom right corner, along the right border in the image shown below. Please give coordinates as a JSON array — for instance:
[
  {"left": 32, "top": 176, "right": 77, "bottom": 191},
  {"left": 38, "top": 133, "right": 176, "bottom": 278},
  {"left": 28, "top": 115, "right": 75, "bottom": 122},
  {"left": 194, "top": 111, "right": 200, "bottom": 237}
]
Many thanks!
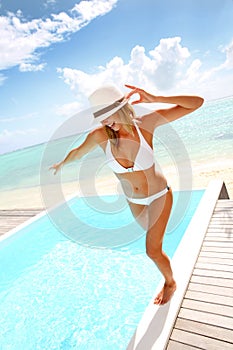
[{"left": 179, "top": 307, "right": 233, "bottom": 330}]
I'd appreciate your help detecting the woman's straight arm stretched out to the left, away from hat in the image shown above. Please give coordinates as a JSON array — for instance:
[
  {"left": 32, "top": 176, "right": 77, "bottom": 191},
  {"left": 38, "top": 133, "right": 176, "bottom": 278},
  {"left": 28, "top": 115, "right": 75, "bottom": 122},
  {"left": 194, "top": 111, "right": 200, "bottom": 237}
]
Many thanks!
[{"left": 49, "top": 130, "right": 100, "bottom": 175}]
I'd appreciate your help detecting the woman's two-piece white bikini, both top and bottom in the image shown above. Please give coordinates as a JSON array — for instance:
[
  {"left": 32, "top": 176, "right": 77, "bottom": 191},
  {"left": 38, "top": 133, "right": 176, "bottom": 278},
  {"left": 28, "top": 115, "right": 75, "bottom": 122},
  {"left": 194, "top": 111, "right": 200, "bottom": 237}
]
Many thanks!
[{"left": 105, "top": 123, "right": 169, "bottom": 205}]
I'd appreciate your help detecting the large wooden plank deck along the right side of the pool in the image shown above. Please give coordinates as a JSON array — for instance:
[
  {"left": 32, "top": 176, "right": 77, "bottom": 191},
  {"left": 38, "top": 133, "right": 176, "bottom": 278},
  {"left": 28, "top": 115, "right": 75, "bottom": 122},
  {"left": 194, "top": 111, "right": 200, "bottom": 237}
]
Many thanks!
[{"left": 166, "top": 199, "right": 233, "bottom": 350}]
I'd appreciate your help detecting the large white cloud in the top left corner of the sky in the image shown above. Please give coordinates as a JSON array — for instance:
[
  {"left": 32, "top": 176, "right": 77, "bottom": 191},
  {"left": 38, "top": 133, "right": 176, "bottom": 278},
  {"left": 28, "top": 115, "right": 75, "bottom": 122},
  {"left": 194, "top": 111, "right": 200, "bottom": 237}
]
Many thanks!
[{"left": 0, "top": 0, "right": 118, "bottom": 70}]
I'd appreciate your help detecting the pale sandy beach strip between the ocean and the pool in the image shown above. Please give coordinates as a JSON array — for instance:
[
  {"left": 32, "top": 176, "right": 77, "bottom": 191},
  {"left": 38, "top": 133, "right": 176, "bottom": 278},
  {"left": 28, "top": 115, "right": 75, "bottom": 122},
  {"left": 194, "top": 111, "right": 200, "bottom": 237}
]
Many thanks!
[{"left": 0, "top": 161, "right": 233, "bottom": 210}]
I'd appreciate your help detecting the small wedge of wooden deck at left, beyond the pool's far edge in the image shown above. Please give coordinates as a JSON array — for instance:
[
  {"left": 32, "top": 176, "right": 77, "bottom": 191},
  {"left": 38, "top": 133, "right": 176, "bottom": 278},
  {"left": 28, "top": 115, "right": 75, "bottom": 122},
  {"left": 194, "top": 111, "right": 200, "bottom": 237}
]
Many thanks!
[{"left": 0, "top": 209, "right": 42, "bottom": 236}]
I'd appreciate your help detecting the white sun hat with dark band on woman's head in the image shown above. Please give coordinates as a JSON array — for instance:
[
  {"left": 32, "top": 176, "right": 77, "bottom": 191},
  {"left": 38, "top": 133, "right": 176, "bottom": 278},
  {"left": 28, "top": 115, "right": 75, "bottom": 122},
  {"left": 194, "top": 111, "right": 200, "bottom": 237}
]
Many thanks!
[{"left": 88, "top": 85, "right": 128, "bottom": 124}]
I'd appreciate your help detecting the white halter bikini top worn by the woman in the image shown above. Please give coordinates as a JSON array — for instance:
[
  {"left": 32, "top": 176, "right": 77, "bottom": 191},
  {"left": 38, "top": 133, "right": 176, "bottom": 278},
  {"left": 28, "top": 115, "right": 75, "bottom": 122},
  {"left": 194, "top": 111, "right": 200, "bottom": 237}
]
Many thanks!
[{"left": 105, "top": 123, "right": 154, "bottom": 173}]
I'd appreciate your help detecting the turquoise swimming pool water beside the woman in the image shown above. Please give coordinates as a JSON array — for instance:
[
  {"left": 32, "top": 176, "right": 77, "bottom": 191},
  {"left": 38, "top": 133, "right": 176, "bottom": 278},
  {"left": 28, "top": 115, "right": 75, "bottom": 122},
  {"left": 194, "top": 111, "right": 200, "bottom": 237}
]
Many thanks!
[{"left": 0, "top": 191, "right": 204, "bottom": 350}]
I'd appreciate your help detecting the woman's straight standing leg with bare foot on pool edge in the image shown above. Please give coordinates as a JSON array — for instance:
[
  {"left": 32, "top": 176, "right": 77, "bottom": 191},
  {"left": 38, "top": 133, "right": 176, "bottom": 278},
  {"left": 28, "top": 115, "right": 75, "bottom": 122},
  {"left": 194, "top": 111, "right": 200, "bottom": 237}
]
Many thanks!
[{"left": 146, "top": 189, "right": 176, "bottom": 304}]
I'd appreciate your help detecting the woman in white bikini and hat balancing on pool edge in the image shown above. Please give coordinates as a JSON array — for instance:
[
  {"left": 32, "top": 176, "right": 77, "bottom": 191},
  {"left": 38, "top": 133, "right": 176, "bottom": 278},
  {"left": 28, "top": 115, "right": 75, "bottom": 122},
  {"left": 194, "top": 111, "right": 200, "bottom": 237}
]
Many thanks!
[{"left": 52, "top": 85, "right": 203, "bottom": 305}]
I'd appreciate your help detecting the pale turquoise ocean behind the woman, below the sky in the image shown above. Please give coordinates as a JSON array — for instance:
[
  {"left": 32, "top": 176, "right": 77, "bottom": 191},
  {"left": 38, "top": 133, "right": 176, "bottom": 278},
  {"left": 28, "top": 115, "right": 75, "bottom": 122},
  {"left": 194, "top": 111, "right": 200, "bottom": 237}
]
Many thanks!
[{"left": 0, "top": 96, "right": 233, "bottom": 191}]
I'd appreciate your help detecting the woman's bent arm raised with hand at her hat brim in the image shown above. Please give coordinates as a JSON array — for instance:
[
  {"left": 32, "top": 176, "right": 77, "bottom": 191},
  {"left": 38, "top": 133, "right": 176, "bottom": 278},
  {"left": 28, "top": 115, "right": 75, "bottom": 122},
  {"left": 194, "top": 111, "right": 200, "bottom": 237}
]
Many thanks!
[{"left": 125, "top": 85, "right": 204, "bottom": 127}]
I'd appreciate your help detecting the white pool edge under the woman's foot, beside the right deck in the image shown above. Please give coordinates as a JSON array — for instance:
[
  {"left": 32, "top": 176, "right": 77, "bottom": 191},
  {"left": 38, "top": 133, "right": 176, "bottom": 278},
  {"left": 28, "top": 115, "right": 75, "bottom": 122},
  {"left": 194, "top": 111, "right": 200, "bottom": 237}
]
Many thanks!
[{"left": 127, "top": 179, "right": 225, "bottom": 350}]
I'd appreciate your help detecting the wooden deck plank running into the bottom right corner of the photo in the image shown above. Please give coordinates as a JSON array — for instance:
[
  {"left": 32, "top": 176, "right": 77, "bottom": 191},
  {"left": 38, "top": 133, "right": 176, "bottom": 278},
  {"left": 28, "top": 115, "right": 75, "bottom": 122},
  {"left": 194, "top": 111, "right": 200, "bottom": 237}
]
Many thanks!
[{"left": 171, "top": 329, "right": 232, "bottom": 350}]
